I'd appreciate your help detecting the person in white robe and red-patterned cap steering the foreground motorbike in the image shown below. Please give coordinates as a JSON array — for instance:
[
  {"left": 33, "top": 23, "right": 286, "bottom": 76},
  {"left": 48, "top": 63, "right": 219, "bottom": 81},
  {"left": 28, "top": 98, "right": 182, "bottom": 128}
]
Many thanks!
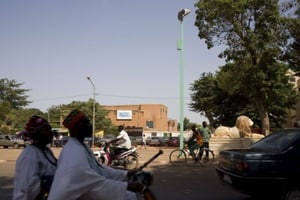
[{"left": 48, "top": 109, "right": 143, "bottom": 200}]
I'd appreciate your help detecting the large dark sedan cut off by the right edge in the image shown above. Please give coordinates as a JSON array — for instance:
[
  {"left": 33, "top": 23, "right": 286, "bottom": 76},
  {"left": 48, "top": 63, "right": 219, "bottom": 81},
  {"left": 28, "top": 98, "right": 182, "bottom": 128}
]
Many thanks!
[{"left": 216, "top": 129, "right": 300, "bottom": 200}]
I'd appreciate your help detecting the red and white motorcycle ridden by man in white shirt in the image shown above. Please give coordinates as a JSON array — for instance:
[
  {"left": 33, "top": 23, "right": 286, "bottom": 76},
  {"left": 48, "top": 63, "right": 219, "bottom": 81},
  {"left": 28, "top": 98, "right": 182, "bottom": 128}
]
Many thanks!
[{"left": 94, "top": 142, "right": 139, "bottom": 169}]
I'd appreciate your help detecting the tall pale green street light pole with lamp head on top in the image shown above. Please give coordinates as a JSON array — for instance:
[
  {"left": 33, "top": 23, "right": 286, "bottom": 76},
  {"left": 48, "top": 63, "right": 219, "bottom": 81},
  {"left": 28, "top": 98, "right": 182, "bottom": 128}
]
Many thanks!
[{"left": 177, "top": 9, "right": 191, "bottom": 149}]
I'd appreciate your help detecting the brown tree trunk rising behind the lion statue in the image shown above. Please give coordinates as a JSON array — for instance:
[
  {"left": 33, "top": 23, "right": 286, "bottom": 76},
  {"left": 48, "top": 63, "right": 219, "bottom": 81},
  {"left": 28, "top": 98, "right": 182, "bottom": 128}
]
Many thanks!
[{"left": 255, "top": 97, "right": 270, "bottom": 136}]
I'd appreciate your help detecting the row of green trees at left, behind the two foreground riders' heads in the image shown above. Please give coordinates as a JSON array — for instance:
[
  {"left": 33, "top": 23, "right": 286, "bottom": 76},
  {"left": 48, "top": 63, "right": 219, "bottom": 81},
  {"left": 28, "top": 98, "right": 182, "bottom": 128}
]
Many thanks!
[{"left": 0, "top": 79, "right": 117, "bottom": 134}]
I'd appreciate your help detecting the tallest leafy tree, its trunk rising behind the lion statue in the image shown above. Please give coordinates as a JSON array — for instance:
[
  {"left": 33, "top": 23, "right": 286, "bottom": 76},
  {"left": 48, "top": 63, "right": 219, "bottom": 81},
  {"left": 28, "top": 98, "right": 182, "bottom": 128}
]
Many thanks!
[{"left": 195, "top": 0, "right": 297, "bottom": 134}]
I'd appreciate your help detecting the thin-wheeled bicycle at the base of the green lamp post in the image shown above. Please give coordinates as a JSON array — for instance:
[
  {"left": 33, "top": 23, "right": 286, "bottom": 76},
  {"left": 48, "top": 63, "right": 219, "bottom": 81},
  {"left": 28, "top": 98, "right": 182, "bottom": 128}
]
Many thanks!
[{"left": 169, "top": 145, "right": 215, "bottom": 166}]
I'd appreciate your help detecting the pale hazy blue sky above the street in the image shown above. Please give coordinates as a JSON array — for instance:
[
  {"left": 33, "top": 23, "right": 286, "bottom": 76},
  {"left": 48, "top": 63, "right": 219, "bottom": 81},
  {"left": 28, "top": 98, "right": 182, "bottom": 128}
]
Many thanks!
[{"left": 0, "top": 0, "right": 224, "bottom": 123}]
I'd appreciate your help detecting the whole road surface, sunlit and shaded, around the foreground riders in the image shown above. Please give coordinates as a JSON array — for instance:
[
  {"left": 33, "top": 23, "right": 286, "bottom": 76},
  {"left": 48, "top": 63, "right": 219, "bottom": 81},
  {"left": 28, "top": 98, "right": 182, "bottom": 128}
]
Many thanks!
[{"left": 0, "top": 147, "right": 253, "bottom": 200}]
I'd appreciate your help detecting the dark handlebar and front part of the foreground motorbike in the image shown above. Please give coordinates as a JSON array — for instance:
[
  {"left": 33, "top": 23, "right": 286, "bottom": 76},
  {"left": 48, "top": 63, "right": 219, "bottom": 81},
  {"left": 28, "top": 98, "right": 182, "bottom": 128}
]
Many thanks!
[{"left": 129, "top": 150, "right": 163, "bottom": 200}]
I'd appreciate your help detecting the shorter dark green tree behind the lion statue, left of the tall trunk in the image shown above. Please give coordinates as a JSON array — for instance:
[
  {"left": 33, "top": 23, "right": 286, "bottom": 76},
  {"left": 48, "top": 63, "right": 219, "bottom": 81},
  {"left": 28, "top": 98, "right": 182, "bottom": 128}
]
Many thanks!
[{"left": 189, "top": 73, "right": 257, "bottom": 127}]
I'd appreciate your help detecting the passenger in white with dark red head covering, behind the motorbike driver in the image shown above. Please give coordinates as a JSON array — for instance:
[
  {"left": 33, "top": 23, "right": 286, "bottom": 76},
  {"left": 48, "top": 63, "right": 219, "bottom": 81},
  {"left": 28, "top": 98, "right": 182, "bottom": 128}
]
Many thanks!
[{"left": 13, "top": 115, "right": 57, "bottom": 200}]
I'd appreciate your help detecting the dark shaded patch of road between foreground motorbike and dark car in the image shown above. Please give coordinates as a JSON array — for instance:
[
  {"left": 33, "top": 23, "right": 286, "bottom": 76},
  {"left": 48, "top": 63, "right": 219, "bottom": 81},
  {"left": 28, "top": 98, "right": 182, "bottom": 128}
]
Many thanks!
[{"left": 145, "top": 164, "right": 250, "bottom": 200}]
